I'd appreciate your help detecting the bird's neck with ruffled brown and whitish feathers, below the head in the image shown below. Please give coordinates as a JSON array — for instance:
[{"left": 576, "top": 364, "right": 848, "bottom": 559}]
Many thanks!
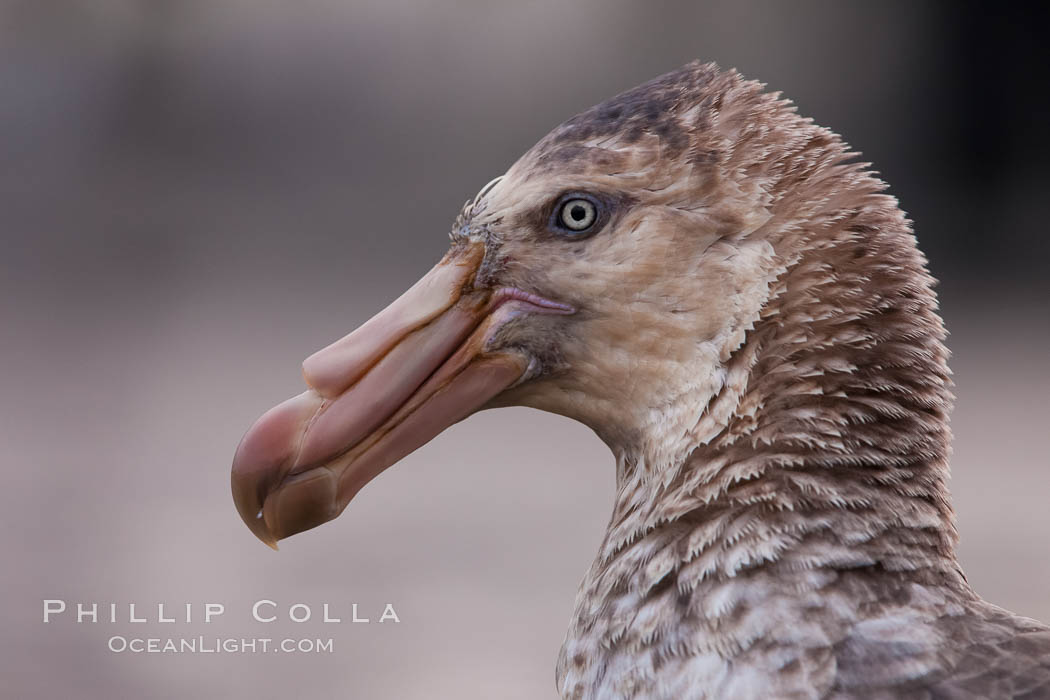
[{"left": 582, "top": 197, "right": 968, "bottom": 633}]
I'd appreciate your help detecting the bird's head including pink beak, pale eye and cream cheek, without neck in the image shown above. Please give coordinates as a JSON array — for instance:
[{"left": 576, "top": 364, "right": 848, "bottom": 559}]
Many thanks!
[{"left": 232, "top": 63, "right": 894, "bottom": 546}]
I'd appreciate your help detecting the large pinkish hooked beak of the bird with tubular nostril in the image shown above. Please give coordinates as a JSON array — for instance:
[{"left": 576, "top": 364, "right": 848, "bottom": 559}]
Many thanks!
[{"left": 232, "top": 243, "right": 529, "bottom": 549}]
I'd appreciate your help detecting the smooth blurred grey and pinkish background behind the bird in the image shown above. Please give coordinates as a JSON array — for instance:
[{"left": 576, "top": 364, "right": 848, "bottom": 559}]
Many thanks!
[{"left": 0, "top": 0, "right": 1050, "bottom": 698}]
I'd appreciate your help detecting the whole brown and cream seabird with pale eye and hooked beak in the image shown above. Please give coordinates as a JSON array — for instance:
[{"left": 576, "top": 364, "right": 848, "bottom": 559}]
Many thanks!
[{"left": 231, "top": 61, "right": 1050, "bottom": 700}]
